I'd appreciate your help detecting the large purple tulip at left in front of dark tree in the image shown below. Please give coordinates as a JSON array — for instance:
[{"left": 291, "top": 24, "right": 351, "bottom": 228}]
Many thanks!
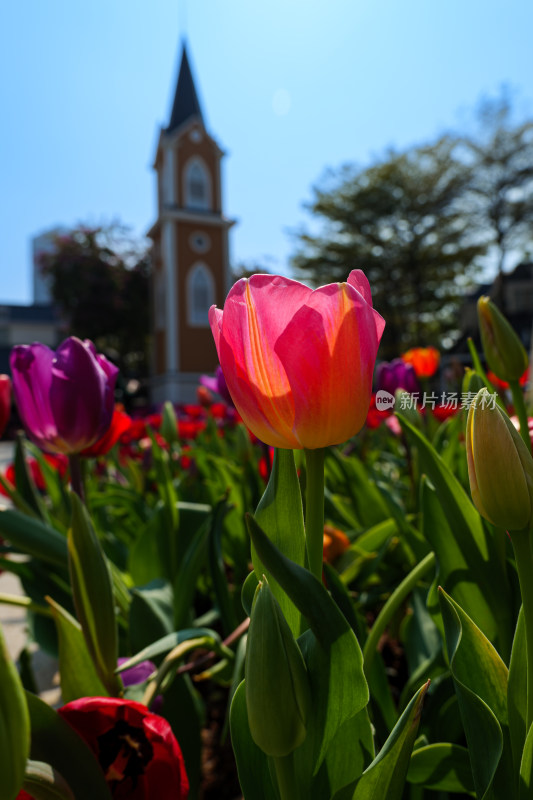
[{"left": 10, "top": 336, "right": 118, "bottom": 455}]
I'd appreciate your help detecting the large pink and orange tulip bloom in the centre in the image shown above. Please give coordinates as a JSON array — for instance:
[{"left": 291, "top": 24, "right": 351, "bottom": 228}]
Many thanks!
[{"left": 209, "top": 270, "right": 385, "bottom": 449}]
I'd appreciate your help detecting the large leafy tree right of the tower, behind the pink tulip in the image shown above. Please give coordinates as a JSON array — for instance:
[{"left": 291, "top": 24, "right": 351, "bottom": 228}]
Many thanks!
[{"left": 292, "top": 137, "right": 486, "bottom": 358}]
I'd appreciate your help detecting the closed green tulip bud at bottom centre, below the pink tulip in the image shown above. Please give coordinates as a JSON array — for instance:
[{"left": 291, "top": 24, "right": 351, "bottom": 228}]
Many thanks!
[{"left": 245, "top": 576, "right": 310, "bottom": 756}]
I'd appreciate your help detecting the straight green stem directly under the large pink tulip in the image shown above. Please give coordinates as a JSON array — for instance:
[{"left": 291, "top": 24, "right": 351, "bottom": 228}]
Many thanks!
[{"left": 304, "top": 447, "right": 326, "bottom": 581}]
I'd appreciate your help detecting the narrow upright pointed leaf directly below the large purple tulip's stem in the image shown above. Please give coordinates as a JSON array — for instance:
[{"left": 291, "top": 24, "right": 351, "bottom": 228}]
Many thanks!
[{"left": 67, "top": 493, "right": 122, "bottom": 695}]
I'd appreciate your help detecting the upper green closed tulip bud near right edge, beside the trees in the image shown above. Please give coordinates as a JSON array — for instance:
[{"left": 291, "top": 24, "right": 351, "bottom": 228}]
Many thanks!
[{"left": 477, "top": 297, "right": 528, "bottom": 382}]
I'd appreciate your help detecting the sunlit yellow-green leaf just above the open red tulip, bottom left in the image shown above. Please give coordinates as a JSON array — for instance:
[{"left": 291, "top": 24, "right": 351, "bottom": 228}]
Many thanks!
[{"left": 48, "top": 598, "right": 109, "bottom": 703}]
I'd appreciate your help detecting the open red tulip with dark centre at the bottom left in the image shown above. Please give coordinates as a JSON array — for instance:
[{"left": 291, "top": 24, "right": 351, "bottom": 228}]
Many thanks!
[{"left": 58, "top": 697, "right": 189, "bottom": 800}]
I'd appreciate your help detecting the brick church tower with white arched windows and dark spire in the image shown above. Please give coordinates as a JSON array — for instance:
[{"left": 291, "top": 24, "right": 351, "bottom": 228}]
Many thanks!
[{"left": 148, "top": 45, "right": 234, "bottom": 403}]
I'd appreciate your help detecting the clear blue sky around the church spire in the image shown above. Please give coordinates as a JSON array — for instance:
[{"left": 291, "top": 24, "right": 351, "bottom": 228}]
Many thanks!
[{"left": 0, "top": 0, "right": 533, "bottom": 303}]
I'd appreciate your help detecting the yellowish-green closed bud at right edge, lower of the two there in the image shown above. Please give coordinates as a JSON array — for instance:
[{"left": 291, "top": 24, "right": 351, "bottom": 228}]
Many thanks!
[{"left": 466, "top": 389, "right": 533, "bottom": 530}]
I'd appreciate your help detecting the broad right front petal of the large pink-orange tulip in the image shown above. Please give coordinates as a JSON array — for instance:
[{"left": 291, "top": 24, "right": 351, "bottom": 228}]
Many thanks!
[{"left": 276, "top": 283, "right": 381, "bottom": 449}]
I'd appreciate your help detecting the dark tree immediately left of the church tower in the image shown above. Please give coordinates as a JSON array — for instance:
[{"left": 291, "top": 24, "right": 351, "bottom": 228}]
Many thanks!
[{"left": 40, "top": 225, "right": 150, "bottom": 378}]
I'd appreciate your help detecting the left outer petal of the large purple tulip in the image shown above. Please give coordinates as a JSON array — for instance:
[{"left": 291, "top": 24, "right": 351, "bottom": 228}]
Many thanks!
[{"left": 10, "top": 342, "right": 57, "bottom": 450}]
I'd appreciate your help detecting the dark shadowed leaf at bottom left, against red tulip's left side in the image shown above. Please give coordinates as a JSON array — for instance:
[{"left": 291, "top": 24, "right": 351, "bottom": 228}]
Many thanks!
[{"left": 25, "top": 692, "right": 112, "bottom": 800}]
